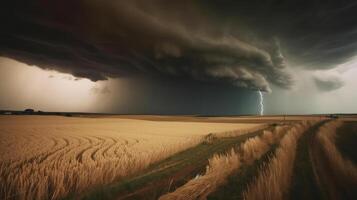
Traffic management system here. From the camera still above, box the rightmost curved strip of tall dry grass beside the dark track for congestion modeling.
[317,121,357,187]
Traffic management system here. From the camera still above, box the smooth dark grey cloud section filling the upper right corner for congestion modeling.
[201,0,357,69]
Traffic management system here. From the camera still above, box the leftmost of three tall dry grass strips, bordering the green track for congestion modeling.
[160,126,288,200]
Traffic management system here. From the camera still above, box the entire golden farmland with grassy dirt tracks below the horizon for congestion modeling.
[0,116,357,200]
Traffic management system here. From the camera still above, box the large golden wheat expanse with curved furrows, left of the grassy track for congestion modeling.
[0,116,257,199]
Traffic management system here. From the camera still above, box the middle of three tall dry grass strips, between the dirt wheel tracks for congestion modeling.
[243,122,310,200]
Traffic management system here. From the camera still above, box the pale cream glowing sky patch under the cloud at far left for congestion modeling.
[0,57,101,112]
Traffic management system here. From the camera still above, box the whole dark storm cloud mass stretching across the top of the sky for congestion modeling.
[0,0,357,91]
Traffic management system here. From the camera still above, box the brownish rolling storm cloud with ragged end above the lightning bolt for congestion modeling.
[0,0,291,91]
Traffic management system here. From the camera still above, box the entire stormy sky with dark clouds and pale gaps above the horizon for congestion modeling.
[0,0,357,115]
